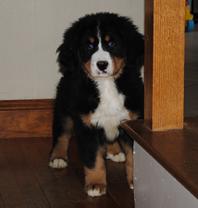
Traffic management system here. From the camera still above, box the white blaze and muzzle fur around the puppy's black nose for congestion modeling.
[91,32,113,77]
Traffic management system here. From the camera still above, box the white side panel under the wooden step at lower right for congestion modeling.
[134,142,198,208]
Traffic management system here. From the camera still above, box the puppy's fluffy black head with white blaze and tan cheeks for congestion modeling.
[58,13,143,79]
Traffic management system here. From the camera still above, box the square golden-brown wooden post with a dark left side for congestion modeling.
[144,0,185,131]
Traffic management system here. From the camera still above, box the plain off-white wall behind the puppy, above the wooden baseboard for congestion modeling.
[0,0,144,100]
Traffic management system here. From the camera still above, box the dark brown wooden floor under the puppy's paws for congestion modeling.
[0,138,134,208]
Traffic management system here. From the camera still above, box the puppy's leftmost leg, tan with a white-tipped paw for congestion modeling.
[49,118,73,169]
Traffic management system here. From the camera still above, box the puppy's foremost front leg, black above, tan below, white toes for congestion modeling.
[75,116,106,197]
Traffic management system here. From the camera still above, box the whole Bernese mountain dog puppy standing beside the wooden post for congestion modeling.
[49,13,144,196]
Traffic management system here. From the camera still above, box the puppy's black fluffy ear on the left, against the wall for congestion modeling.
[57,28,78,75]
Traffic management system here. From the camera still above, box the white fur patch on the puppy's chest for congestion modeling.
[91,78,129,141]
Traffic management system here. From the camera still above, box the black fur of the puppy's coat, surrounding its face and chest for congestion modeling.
[53,13,144,168]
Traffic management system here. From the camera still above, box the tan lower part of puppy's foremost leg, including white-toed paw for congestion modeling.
[84,148,106,197]
